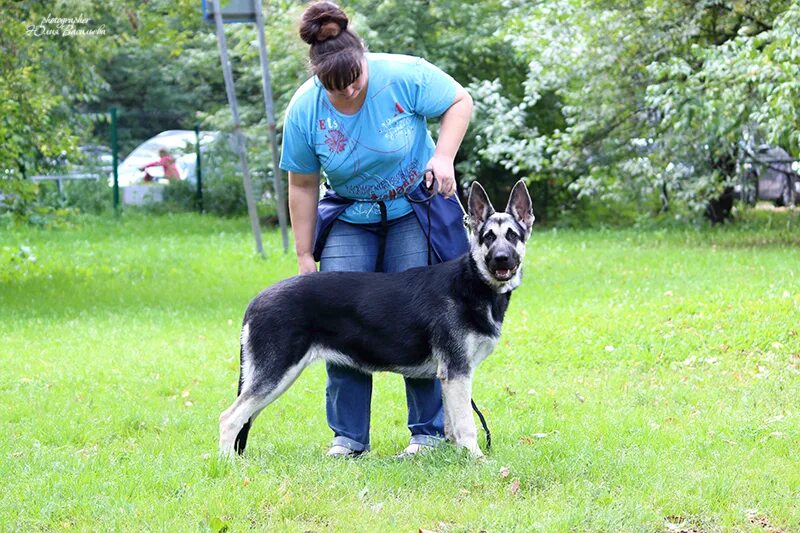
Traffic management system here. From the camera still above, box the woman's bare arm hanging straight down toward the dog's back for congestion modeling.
[289,171,319,274]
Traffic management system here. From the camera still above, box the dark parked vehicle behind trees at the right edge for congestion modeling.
[734,145,800,207]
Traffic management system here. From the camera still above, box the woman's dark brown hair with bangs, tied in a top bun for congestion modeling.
[300,1,365,90]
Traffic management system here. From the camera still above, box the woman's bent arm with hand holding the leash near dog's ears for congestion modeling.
[426,85,472,198]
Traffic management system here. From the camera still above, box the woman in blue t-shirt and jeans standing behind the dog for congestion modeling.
[280,2,472,456]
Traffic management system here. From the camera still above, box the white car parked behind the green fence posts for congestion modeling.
[109,130,219,187]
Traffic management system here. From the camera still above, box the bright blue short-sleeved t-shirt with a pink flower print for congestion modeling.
[280,54,458,224]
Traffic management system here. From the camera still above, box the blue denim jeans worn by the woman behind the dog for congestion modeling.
[319,213,444,451]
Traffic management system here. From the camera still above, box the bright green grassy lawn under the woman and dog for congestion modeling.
[0,213,800,532]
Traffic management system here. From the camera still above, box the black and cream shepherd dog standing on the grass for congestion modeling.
[219,180,534,457]
